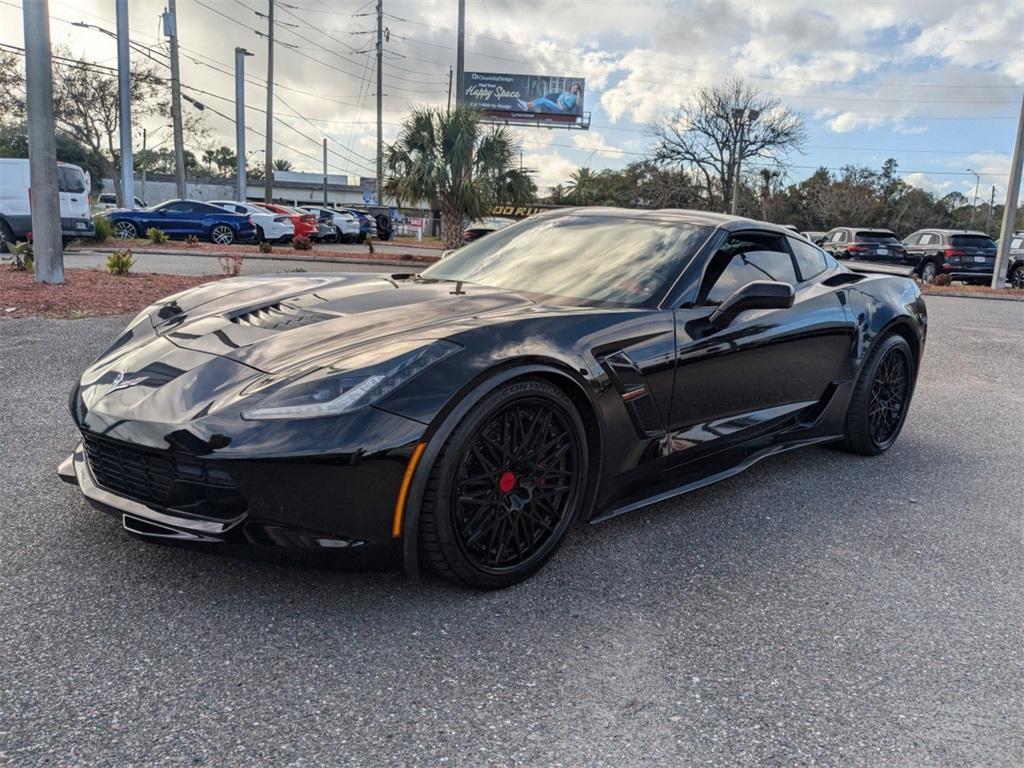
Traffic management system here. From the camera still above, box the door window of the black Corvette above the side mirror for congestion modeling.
[697,232,798,304]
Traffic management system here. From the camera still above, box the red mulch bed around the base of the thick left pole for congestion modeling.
[0,269,223,318]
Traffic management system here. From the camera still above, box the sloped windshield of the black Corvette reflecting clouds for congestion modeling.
[423,214,711,306]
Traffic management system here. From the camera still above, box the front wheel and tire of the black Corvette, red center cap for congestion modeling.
[419,379,588,590]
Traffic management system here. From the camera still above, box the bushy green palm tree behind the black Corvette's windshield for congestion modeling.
[383,106,536,248]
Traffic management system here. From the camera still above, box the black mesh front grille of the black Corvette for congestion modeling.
[82,432,246,520]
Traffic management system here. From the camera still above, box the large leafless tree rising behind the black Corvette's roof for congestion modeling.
[647,78,806,210]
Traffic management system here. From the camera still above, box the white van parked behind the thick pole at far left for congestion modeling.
[0,158,96,253]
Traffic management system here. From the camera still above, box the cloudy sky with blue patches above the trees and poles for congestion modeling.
[0,0,1024,197]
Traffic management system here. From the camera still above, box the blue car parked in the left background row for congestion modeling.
[97,200,256,246]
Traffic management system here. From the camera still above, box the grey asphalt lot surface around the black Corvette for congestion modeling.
[0,297,1024,768]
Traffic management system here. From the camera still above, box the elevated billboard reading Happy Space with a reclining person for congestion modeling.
[462,72,586,124]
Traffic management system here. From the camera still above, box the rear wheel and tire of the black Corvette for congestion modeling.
[842,334,915,456]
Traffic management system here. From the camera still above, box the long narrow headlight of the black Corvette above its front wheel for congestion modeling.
[242,341,462,420]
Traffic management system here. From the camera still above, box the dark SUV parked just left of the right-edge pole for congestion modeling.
[903,229,995,283]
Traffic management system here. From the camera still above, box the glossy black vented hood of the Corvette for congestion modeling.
[100,274,535,374]
